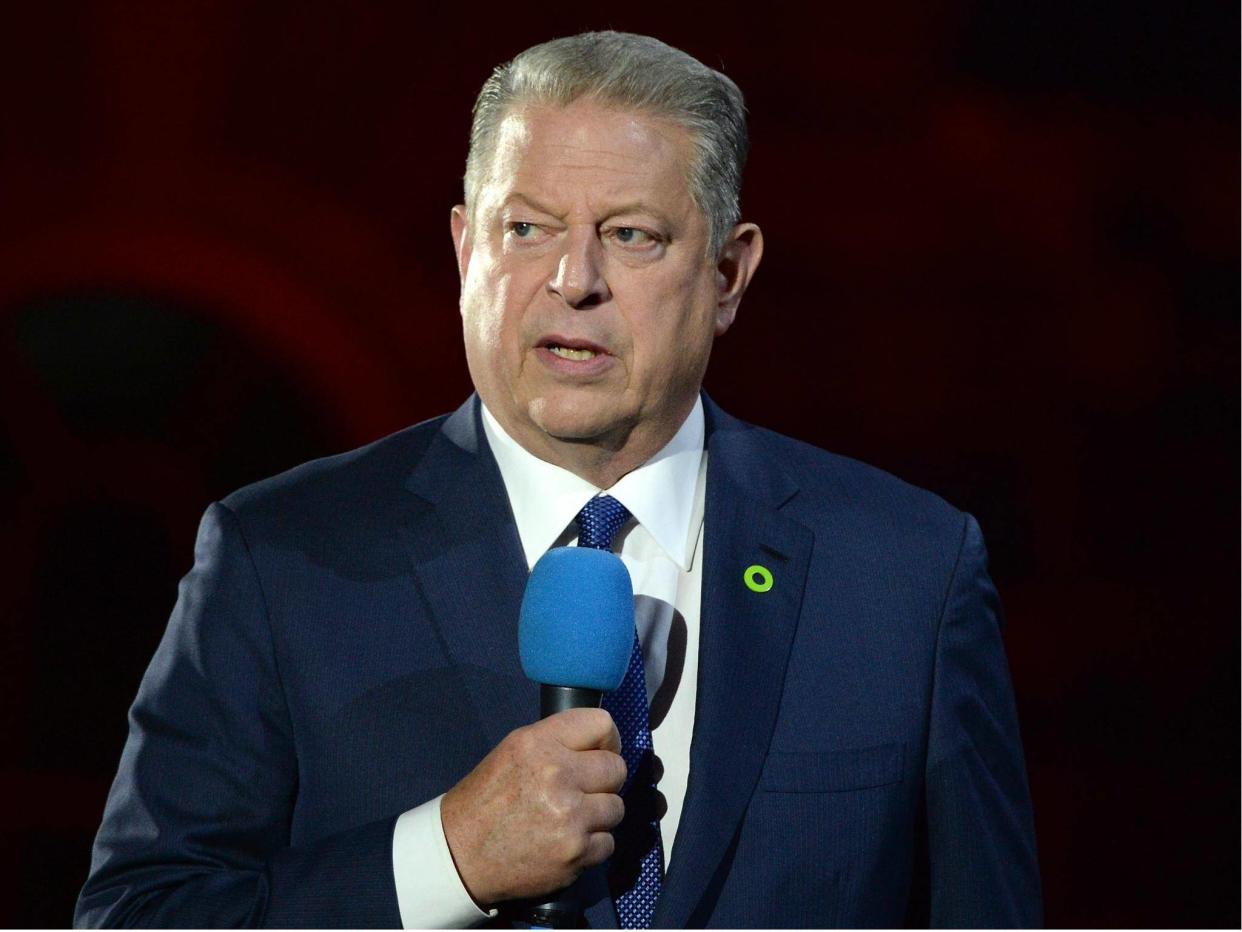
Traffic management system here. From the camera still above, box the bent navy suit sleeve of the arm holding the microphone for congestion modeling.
[75,505,401,928]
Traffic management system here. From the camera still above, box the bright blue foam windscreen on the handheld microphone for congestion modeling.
[518,547,635,692]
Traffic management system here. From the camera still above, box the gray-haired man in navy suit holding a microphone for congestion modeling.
[77,32,1040,927]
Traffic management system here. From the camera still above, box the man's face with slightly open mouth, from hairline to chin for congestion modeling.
[453,101,758,464]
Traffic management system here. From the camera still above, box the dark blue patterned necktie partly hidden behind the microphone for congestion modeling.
[575,495,664,928]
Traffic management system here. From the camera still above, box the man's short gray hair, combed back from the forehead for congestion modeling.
[466,31,749,255]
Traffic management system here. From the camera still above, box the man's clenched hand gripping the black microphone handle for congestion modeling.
[440,708,626,907]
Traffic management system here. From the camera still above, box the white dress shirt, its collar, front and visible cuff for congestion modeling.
[392,400,707,928]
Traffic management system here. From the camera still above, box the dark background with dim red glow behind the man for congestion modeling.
[0,1,1240,927]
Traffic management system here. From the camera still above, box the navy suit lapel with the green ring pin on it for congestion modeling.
[652,399,814,928]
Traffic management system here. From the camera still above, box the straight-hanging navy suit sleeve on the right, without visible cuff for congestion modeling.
[925,516,1042,928]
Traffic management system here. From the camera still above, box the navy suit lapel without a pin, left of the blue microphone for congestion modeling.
[401,396,539,748]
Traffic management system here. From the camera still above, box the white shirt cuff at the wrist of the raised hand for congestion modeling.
[392,795,497,928]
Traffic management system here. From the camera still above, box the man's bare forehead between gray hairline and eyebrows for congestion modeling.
[486,101,693,214]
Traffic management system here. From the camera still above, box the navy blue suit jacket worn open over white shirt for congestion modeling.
[76,399,1041,927]
